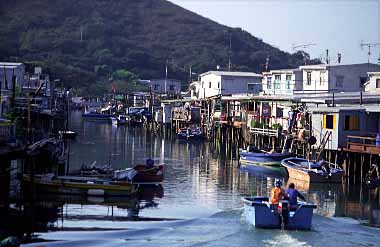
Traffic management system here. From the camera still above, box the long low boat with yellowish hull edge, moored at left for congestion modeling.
[23,174,137,196]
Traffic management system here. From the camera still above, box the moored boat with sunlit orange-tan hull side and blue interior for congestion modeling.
[281,158,344,183]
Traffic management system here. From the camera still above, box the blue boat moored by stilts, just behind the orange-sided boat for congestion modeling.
[239,146,295,166]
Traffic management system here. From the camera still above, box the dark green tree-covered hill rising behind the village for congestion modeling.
[0,0,316,91]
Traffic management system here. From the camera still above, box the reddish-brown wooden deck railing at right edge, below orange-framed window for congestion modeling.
[346,135,380,155]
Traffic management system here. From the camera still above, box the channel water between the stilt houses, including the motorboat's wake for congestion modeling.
[19,112,380,246]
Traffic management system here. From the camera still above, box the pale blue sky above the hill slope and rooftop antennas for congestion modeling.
[170,0,380,63]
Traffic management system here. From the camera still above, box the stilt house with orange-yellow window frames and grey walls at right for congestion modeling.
[309,104,380,151]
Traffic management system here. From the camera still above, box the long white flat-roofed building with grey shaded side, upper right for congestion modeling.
[262,63,380,95]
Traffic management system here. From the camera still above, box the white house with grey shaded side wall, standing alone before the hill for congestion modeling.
[198,71,262,99]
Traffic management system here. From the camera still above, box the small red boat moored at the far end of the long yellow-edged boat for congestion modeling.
[114,165,164,184]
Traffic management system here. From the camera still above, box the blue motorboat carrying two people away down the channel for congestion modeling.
[242,196,317,230]
